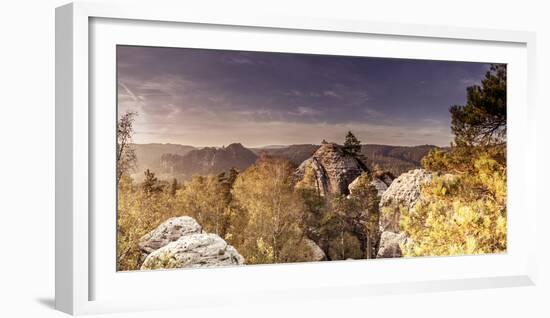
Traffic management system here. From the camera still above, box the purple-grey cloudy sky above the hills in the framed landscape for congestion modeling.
[117,46,496,147]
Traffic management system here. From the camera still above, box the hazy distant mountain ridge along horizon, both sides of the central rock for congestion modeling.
[130,143,438,181]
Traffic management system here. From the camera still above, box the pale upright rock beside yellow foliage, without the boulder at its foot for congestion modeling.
[380,169,432,232]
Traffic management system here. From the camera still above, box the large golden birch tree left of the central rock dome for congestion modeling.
[232,157,310,264]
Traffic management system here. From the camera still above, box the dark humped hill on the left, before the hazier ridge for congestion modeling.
[160,143,257,180]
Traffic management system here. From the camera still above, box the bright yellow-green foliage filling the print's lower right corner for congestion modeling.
[400,155,506,256]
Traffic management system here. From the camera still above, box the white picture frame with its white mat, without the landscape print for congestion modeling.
[55,2,537,314]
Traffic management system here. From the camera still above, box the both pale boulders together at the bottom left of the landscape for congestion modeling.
[139,216,244,269]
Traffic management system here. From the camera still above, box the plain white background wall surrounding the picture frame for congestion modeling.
[0,0,550,317]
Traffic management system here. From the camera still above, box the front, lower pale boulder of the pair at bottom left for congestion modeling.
[141,233,244,270]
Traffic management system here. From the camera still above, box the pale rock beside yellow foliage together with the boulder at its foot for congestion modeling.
[376,169,432,258]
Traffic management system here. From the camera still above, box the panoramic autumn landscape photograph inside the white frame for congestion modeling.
[113,45,507,271]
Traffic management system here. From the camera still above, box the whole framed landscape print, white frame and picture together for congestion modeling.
[56,3,536,314]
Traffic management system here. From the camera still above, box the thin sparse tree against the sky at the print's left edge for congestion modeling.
[116,112,137,184]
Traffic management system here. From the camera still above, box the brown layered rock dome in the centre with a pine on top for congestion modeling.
[295,143,368,196]
